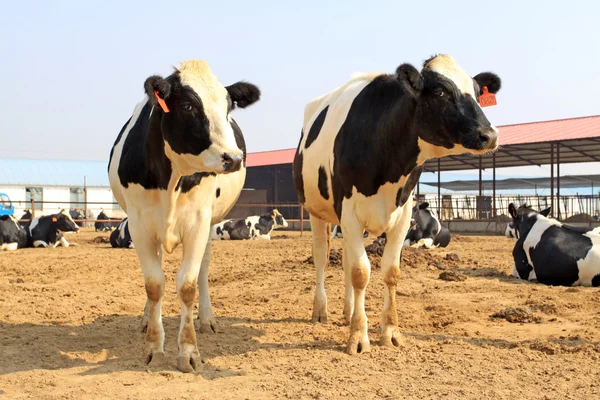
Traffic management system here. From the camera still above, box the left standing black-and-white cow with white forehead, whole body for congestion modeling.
[108,60,260,372]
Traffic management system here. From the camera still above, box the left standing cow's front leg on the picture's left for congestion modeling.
[130,223,165,366]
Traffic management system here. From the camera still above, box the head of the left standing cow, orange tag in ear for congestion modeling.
[144,60,260,175]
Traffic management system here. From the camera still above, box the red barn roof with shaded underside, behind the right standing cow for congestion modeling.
[247,115,600,172]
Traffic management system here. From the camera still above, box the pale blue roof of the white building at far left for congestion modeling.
[0,158,110,187]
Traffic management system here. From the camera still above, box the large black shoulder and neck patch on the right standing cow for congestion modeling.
[331,75,419,218]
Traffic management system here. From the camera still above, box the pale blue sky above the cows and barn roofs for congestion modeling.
[0,0,600,189]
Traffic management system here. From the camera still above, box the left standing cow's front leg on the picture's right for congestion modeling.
[177,210,211,372]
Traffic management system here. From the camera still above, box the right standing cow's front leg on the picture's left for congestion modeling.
[341,212,371,354]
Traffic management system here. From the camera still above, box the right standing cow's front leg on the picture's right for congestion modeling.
[379,202,411,347]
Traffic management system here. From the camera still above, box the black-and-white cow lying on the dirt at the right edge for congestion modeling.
[508,203,600,287]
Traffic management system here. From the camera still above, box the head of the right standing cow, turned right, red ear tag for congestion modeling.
[396,55,501,158]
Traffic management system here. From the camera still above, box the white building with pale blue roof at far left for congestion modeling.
[0,158,125,218]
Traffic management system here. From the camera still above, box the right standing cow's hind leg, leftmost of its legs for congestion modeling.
[310,215,331,323]
